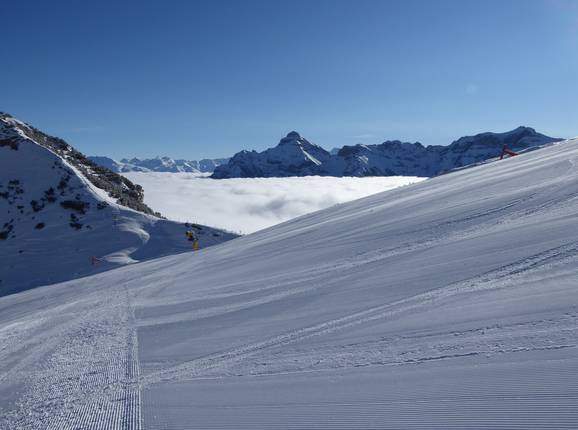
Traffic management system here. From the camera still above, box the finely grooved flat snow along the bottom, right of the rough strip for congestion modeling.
[144,359,578,430]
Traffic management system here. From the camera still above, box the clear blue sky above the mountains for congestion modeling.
[0,0,578,159]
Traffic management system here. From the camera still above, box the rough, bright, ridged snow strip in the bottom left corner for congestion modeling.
[0,286,141,430]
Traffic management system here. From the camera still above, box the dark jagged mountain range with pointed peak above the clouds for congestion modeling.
[212,127,560,179]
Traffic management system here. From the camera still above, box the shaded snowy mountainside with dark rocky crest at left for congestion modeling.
[0,113,234,296]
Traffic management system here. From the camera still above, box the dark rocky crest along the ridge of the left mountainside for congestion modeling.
[0,112,160,216]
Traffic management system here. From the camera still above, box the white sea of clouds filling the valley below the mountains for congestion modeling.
[123,172,424,234]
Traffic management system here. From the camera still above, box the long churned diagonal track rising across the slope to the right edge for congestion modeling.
[141,243,578,386]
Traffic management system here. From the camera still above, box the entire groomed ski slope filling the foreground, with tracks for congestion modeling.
[0,140,578,429]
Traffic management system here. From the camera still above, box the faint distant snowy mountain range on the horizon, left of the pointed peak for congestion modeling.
[88,156,229,173]
